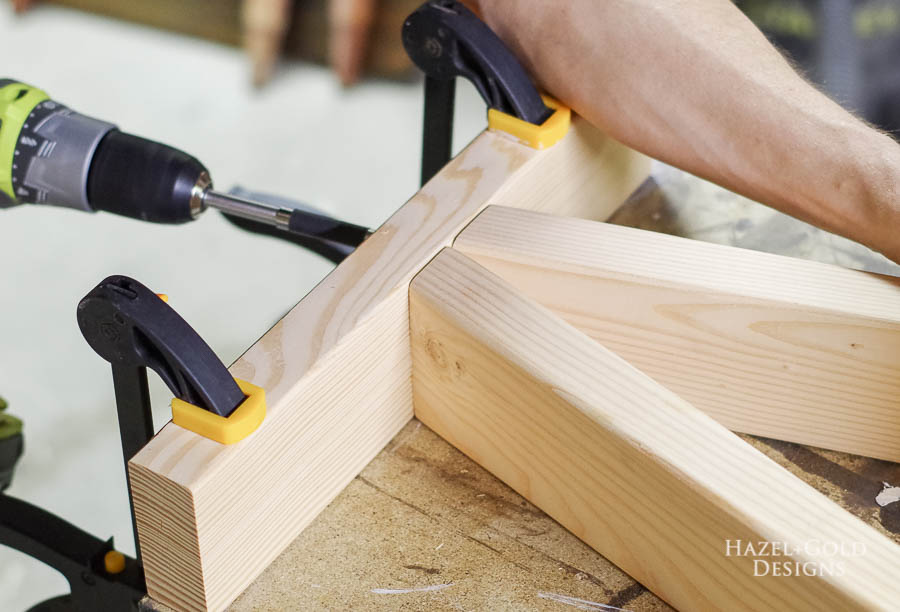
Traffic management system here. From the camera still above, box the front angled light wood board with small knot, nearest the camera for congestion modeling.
[410,249,900,612]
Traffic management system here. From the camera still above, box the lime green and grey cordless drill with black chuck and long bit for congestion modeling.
[0,79,369,246]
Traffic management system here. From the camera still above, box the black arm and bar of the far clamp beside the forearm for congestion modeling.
[403,0,553,184]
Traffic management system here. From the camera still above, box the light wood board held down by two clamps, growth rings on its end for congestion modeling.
[129,120,649,610]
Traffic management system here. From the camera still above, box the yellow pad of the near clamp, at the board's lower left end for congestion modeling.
[172,378,266,444]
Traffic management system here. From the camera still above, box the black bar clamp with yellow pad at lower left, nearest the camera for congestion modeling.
[0,276,265,612]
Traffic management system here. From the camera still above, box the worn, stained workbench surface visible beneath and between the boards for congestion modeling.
[151,168,900,611]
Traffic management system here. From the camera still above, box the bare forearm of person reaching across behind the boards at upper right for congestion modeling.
[480,0,900,260]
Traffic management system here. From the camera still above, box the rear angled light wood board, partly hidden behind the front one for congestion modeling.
[455,207,900,461]
